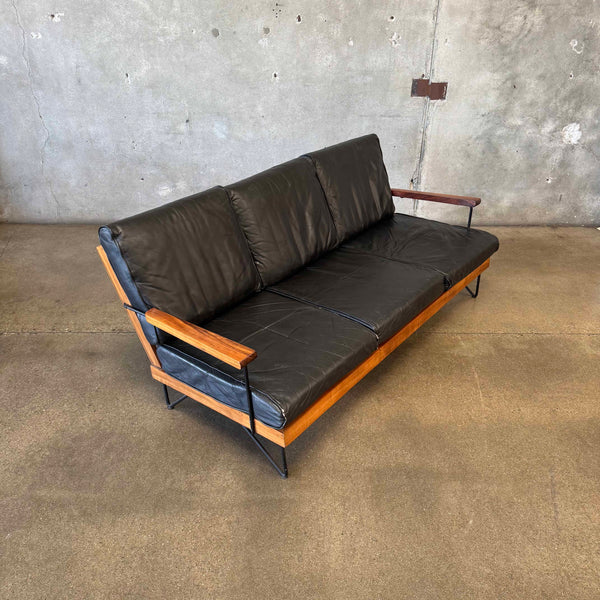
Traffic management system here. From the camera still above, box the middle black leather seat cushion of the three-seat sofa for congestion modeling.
[268,249,444,345]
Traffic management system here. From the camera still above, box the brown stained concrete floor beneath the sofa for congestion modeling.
[0,225,600,600]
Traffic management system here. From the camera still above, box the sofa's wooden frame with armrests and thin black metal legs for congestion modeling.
[96,189,490,478]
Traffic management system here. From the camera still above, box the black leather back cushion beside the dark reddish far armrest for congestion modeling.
[307,134,394,242]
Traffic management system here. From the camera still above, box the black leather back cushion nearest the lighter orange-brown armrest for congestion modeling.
[100,188,260,323]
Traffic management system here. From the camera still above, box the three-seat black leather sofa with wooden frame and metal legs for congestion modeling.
[98,135,498,476]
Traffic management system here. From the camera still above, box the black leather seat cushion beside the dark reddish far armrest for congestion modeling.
[342,213,498,286]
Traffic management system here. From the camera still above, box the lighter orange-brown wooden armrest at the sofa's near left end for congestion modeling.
[144,308,256,369]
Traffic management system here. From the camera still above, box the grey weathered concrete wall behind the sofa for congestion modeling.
[0,0,600,224]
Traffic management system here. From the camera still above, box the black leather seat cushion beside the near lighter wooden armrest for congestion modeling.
[157,291,377,429]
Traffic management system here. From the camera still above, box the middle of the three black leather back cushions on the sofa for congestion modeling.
[227,157,336,285]
